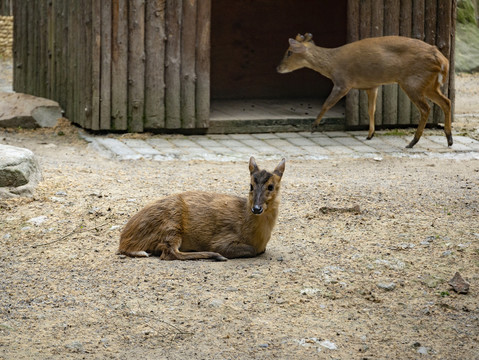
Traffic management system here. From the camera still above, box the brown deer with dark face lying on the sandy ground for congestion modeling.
[118,157,285,261]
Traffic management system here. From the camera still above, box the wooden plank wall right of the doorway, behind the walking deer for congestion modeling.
[346,0,457,128]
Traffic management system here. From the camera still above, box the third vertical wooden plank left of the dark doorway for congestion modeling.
[165,0,182,129]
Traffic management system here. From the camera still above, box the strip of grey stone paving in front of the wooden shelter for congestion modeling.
[82,131,479,161]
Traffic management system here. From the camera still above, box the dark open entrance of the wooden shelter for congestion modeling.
[210,0,347,131]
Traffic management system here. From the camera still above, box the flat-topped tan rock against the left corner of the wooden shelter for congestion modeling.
[0,92,62,129]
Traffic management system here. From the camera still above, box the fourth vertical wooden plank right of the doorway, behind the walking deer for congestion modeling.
[382,0,399,125]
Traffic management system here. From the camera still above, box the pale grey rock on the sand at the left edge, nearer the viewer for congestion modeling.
[0,144,42,199]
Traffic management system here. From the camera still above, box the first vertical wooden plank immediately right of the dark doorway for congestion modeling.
[346,0,359,127]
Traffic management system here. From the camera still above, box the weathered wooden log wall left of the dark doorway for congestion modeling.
[14,0,211,132]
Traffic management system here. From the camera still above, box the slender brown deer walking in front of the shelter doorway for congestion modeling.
[277,33,452,148]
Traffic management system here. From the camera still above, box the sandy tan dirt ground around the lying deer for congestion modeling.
[0,75,479,359]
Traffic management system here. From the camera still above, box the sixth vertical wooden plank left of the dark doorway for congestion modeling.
[111,0,128,130]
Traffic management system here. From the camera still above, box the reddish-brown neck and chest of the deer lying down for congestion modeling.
[243,198,279,253]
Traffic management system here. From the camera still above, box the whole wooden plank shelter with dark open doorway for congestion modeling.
[14,0,456,132]
